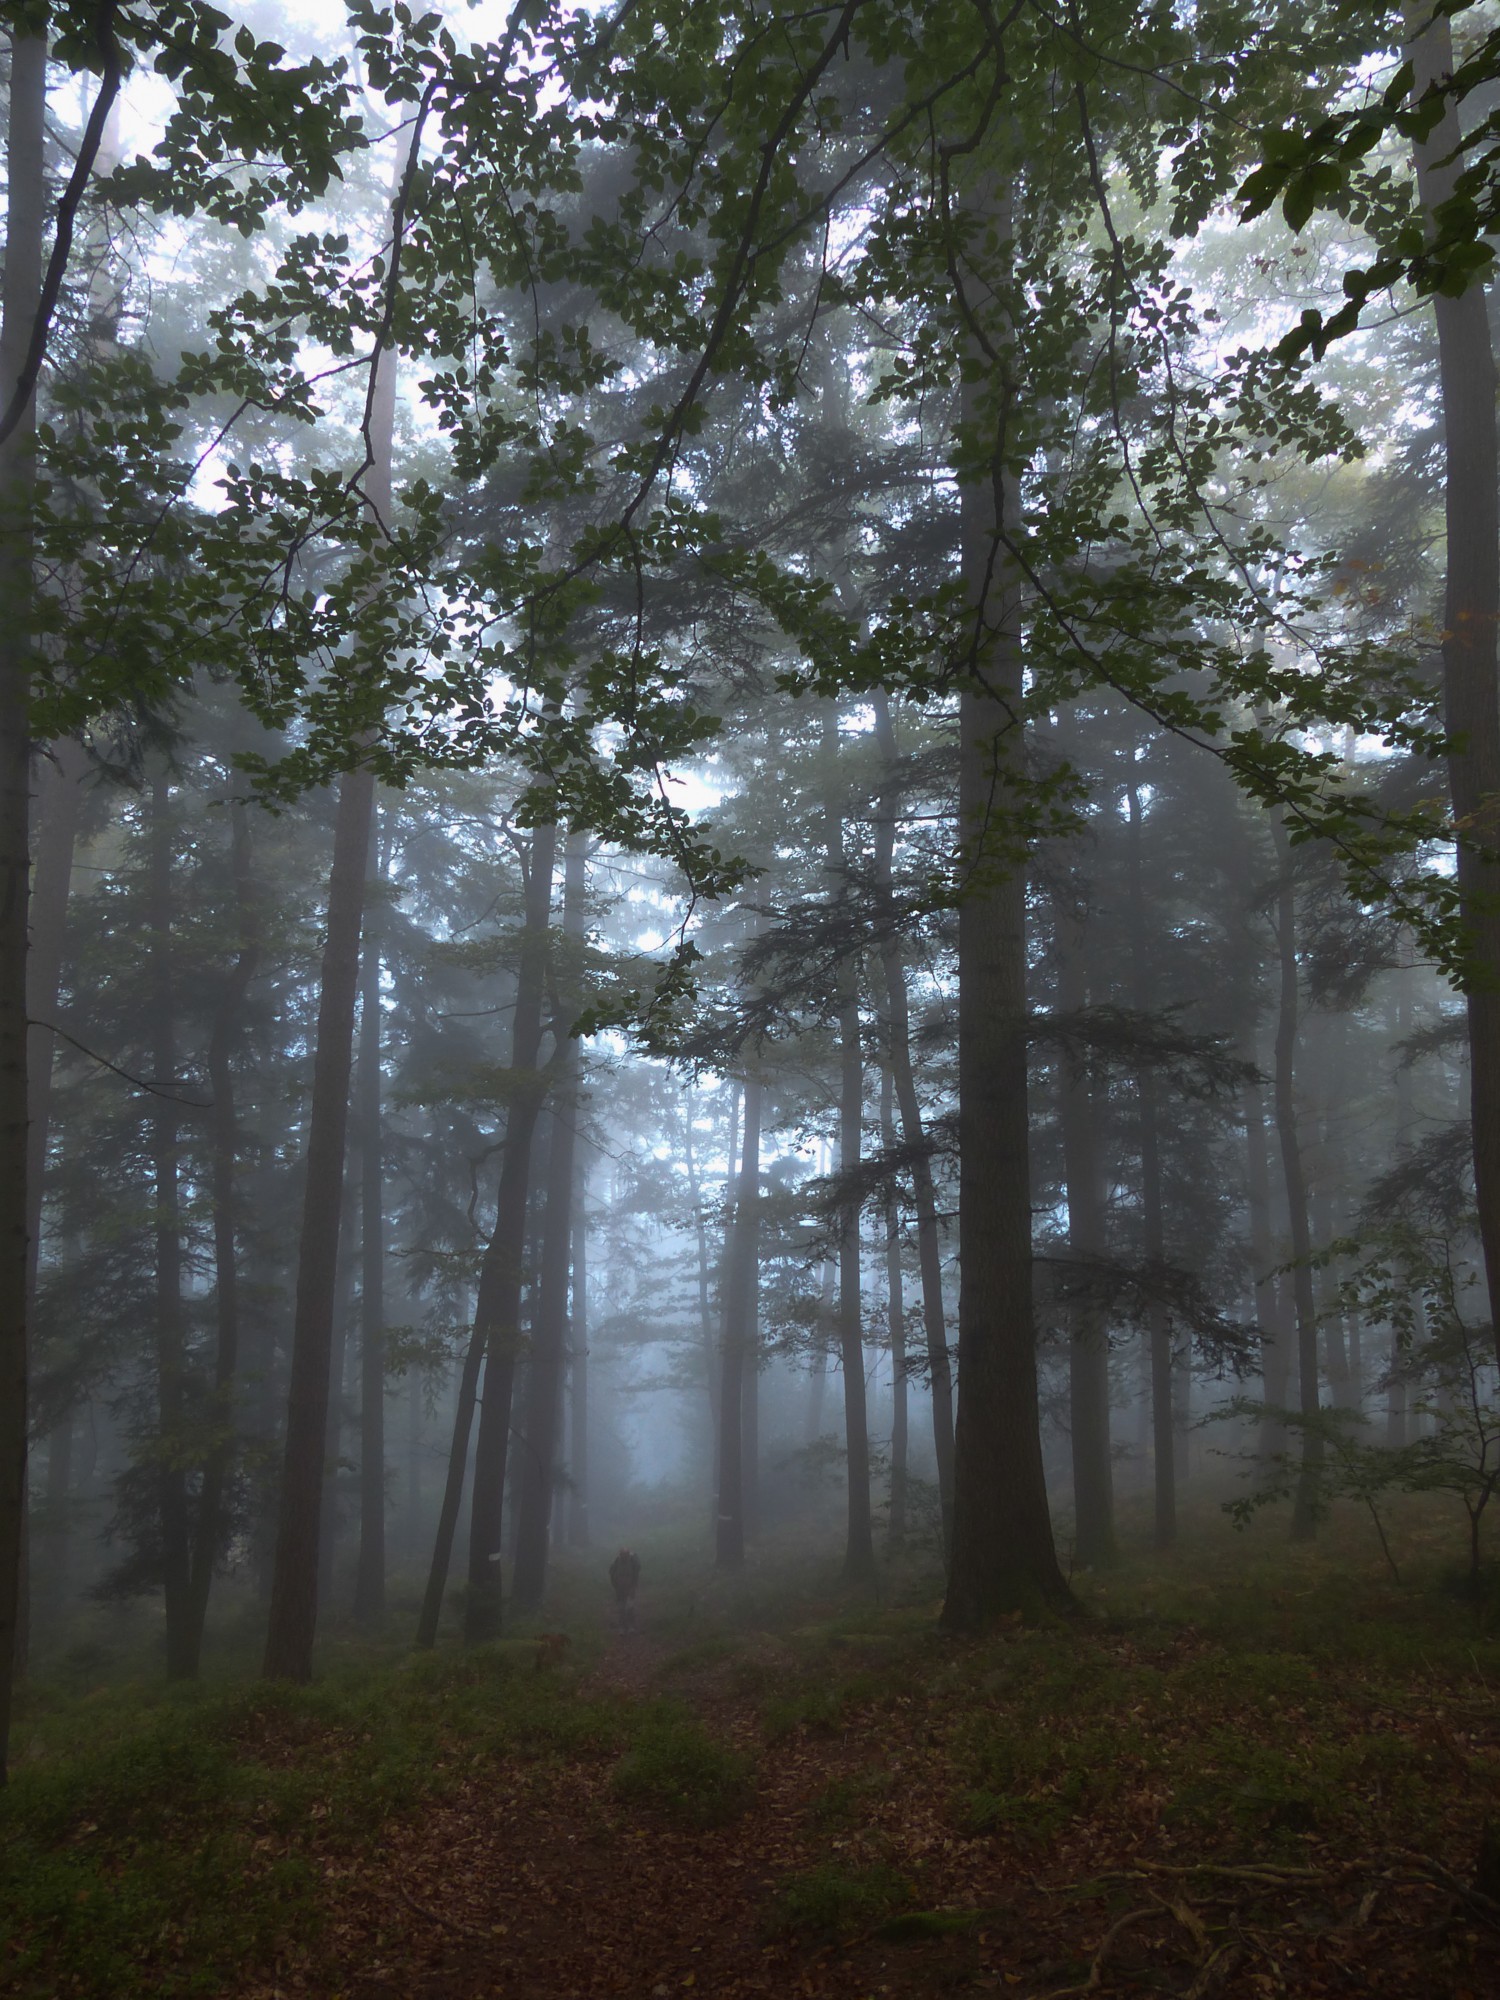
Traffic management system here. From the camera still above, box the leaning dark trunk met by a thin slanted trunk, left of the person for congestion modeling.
[458,826,558,1642]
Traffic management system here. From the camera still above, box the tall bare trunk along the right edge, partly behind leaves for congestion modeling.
[1404,0,1500,1340]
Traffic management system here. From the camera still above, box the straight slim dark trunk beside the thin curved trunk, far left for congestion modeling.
[146,778,198,1680]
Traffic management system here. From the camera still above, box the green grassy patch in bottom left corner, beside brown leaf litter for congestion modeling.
[0,1642,636,2000]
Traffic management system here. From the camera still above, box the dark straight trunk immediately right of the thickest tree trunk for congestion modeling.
[1058,914,1118,1570]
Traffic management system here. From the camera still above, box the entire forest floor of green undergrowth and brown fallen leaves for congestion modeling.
[0,1504,1500,2000]
